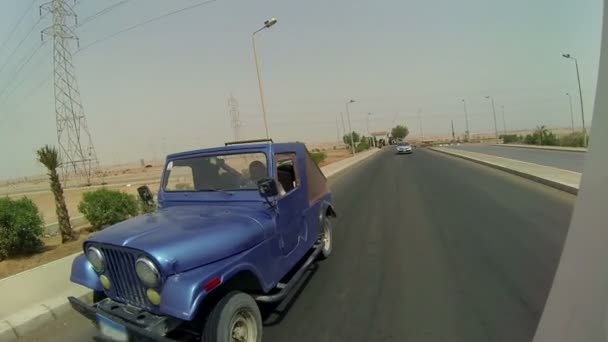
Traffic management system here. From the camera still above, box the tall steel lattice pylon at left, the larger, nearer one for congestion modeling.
[40,0,99,184]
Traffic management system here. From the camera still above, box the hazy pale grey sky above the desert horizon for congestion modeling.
[0,0,602,178]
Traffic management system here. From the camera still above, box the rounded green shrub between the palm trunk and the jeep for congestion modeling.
[78,189,139,230]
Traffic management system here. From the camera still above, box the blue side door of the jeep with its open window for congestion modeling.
[273,152,307,257]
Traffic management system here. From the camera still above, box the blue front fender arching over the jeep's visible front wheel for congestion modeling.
[160,240,278,321]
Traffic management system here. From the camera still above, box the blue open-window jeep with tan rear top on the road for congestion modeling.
[69,140,336,342]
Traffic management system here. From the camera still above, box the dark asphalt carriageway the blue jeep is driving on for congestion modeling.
[23,149,575,342]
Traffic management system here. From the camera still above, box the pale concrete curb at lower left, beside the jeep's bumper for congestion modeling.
[0,289,93,342]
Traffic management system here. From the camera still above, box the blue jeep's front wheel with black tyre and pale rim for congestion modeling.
[201,291,262,342]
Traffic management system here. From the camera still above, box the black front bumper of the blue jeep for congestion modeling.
[68,297,181,342]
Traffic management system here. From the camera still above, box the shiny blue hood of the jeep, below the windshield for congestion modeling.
[87,205,271,275]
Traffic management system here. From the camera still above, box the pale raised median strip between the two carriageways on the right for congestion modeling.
[431,147,581,195]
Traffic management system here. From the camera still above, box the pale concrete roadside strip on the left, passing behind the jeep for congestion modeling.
[0,148,380,342]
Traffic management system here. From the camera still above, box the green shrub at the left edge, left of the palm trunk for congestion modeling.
[0,197,44,260]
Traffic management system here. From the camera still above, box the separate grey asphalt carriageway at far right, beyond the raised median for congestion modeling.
[451,145,586,173]
